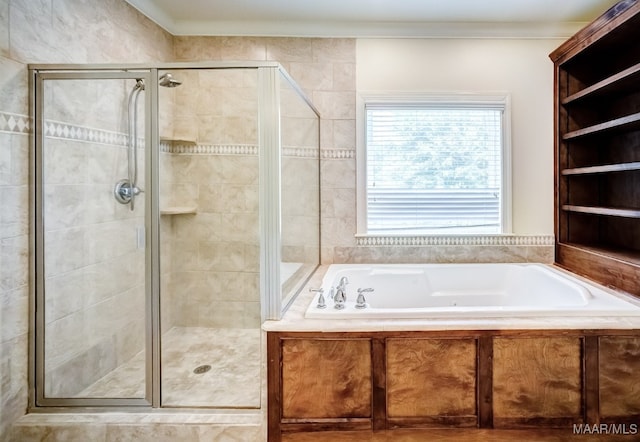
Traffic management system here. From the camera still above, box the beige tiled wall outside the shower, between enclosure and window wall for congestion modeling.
[175,37,356,263]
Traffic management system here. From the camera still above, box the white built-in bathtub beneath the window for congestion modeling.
[305,264,640,319]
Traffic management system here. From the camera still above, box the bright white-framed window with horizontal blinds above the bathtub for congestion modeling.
[359,97,509,235]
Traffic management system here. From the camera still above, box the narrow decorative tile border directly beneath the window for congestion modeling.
[356,235,555,246]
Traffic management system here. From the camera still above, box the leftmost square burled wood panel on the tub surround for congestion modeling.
[282,339,371,418]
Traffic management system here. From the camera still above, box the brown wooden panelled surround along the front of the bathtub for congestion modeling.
[267,330,640,442]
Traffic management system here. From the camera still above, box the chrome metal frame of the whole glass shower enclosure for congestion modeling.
[29,61,320,412]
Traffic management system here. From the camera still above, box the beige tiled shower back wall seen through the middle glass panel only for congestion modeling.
[160,69,260,329]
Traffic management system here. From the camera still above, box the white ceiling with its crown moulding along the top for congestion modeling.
[126,0,617,38]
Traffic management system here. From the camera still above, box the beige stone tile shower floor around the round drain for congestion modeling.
[78,327,261,408]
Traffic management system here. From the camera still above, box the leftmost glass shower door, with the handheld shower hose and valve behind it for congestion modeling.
[35,72,151,405]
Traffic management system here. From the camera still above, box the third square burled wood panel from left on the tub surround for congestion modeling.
[493,337,582,426]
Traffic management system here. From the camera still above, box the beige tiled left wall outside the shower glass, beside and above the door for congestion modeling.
[0,0,173,440]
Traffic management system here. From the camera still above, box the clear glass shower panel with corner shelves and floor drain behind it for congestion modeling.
[158,68,262,408]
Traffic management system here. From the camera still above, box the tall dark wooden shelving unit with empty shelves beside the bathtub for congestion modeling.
[550,0,640,296]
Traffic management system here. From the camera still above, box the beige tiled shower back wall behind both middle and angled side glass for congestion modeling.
[160,69,319,330]
